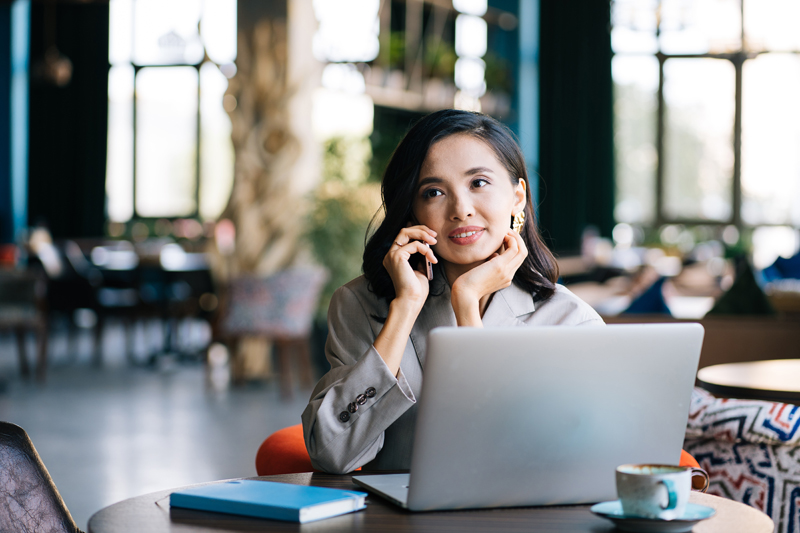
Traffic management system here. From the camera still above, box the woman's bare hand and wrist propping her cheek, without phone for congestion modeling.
[450,229,528,326]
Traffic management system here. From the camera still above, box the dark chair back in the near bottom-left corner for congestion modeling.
[0,422,81,533]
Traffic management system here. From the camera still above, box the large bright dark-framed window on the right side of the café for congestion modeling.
[612,0,800,228]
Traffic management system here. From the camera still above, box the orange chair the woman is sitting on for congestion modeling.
[256,424,700,476]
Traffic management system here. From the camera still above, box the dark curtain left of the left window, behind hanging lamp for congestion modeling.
[28,2,109,238]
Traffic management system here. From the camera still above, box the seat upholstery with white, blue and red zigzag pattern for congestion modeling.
[684,388,800,533]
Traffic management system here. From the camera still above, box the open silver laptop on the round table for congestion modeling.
[353,324,704,511]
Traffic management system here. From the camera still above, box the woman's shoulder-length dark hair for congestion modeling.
[363,109,558,302]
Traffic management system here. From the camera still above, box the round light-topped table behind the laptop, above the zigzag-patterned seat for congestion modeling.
[697,359,800,404]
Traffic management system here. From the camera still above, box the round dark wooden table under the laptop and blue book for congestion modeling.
[89,473,774,533]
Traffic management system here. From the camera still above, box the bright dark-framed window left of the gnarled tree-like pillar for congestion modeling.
[106,0,236,222]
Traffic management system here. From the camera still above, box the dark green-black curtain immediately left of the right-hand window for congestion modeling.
[538,0,614,254]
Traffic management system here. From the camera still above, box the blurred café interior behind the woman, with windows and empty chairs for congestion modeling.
[0,0,800,533]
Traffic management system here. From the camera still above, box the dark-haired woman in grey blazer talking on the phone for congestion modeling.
[303,110,603,473]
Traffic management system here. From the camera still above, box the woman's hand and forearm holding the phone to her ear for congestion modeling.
[373,226,439,376]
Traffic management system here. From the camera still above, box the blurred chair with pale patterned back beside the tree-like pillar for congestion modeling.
[215,267,328,397]
